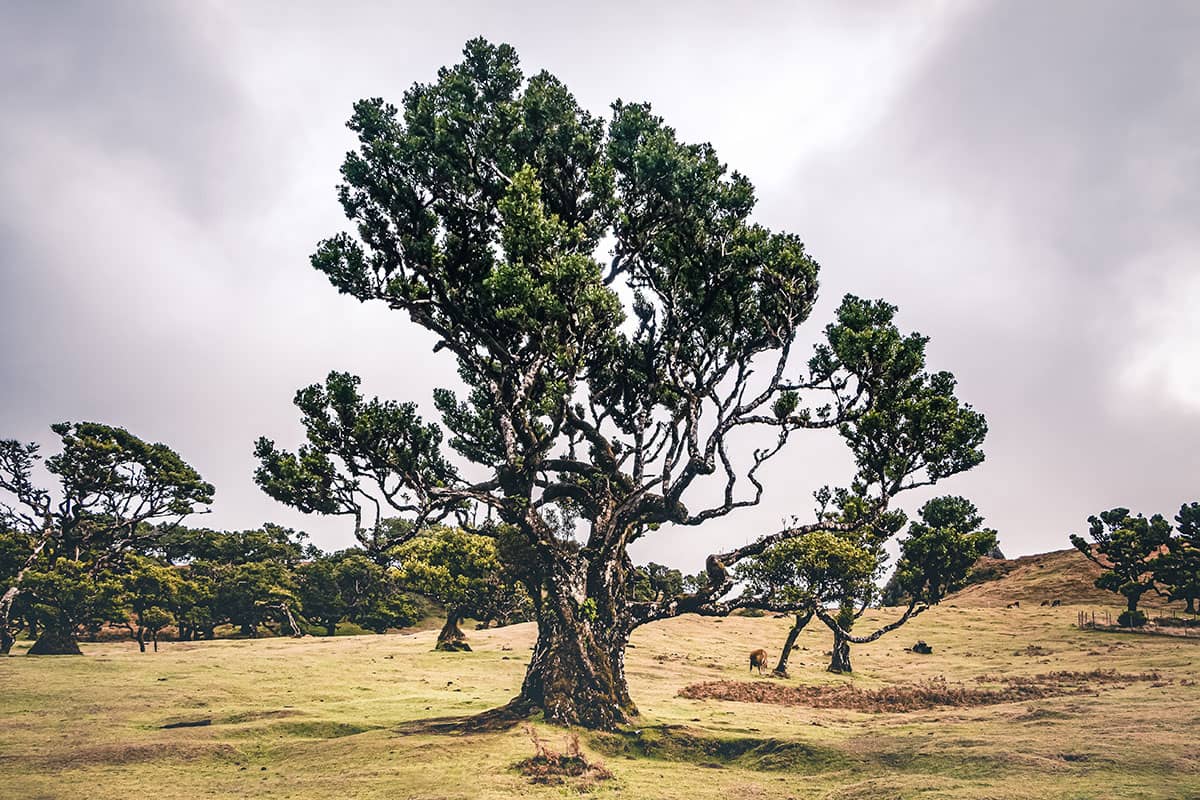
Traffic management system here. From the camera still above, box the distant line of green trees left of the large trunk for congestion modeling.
[0,524,530,650]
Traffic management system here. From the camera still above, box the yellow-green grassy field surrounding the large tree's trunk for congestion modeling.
[0,606,1200,800]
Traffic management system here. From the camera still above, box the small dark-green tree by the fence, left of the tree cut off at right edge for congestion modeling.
[1070,509,1171,627]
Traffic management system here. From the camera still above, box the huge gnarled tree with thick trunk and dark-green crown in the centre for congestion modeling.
[257,40,985,728]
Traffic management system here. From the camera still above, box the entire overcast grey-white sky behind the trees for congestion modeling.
[0,0,1200,570]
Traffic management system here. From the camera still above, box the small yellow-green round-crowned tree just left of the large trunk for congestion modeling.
[391,525,511,650]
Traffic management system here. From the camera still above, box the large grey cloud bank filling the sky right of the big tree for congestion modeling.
[729,2,1200,563]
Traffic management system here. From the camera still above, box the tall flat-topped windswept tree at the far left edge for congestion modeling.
[0,422,214,654]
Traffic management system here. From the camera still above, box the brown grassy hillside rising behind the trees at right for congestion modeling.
[946,548,1183,609]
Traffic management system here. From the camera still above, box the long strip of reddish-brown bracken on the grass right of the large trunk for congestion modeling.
[679,669,1163,714]
